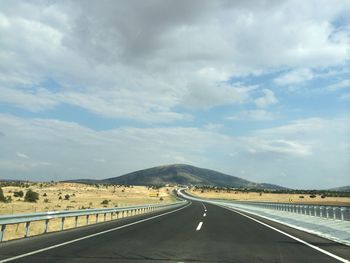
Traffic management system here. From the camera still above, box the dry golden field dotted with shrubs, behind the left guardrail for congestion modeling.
[0,183,175,241]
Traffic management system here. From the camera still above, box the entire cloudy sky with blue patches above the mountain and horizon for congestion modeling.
[0,0,350,188]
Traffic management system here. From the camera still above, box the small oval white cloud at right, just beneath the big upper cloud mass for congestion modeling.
[274,68,314,86]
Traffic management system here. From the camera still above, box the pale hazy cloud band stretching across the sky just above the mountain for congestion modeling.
[0,114,350,188]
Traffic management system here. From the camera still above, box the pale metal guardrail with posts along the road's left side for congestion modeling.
[0,201,187,242]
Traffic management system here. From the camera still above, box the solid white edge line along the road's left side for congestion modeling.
[0,202,192,263]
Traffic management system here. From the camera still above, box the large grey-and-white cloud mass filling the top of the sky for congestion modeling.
[0,1,350,123]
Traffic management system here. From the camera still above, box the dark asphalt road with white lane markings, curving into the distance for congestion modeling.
[0,202,350,263]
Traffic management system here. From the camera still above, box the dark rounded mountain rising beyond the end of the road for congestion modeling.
[65,164,287,190]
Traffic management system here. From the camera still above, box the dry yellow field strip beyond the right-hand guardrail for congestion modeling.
[188,189,350,206]
